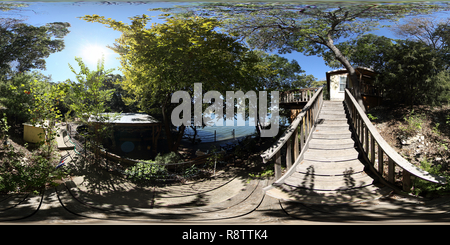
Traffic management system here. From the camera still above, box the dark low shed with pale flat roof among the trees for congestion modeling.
[89,113,162,157]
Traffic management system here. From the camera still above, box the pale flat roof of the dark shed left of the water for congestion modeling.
[89,113,160,126]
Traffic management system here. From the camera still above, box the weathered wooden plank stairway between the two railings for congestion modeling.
[266,101,391,204]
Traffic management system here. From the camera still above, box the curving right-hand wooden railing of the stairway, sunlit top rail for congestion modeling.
[345,89,446,191]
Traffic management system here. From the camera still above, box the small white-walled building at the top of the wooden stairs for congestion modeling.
[326,67,382,109]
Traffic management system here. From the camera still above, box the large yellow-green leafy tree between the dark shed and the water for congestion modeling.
[82,15,258,152]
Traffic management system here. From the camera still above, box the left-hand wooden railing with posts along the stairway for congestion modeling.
[261,87,323,179]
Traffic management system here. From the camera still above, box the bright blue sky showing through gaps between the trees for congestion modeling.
[5,2,444,82]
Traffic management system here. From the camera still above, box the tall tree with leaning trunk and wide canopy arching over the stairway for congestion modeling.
[153,3,447,111]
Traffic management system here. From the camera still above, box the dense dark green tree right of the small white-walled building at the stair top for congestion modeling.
[377,41,445,106]
